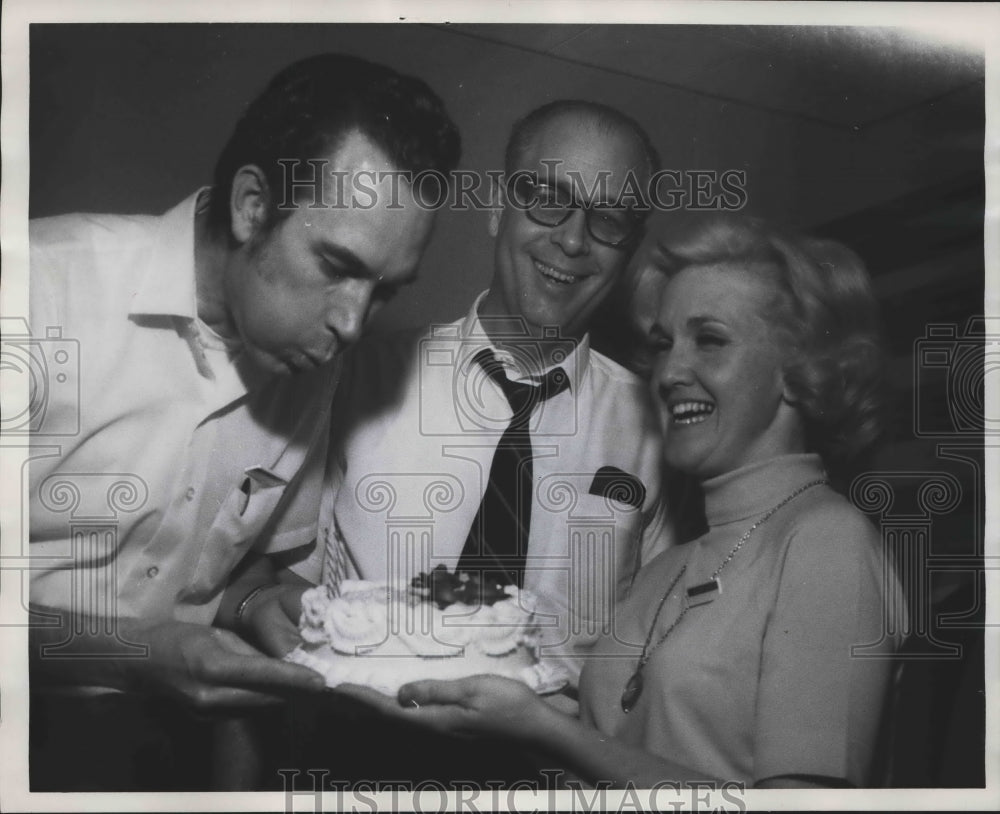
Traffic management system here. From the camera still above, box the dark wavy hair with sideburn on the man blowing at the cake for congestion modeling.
[209,54,461,233]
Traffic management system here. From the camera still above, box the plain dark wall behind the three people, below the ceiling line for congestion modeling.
[30,24,982,334]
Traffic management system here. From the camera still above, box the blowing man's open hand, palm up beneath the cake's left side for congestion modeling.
[126,621,325,707]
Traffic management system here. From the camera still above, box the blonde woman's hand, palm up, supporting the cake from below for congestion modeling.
[337,675,559,740]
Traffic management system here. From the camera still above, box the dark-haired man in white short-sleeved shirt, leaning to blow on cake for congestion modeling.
[29,54,459,706]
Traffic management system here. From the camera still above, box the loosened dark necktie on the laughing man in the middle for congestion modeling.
[458,348,569,587]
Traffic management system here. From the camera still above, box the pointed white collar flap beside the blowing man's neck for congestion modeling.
[129,187,210,320]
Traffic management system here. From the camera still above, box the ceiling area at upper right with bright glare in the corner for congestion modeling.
[434,24,984,130]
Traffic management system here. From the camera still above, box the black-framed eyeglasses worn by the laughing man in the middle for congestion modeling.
[507,173,643,249]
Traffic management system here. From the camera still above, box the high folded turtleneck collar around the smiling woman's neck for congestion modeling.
[702,453,826,526]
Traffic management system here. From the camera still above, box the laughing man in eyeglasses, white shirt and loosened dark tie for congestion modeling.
[297,101,663,712]
